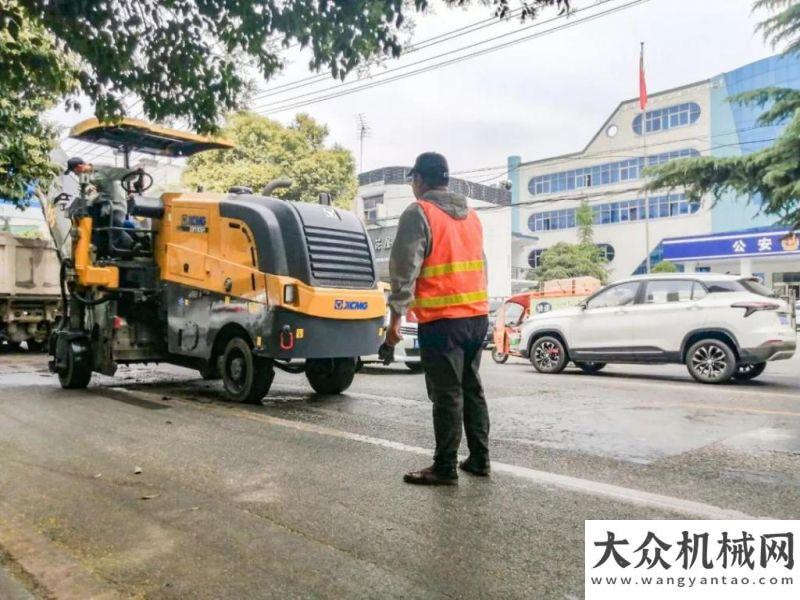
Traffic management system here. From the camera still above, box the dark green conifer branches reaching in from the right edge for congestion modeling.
[647,0,800,229]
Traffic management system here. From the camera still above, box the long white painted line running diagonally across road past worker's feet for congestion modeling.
[113,388,766,520]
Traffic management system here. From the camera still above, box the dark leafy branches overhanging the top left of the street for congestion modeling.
[0,0,569,206]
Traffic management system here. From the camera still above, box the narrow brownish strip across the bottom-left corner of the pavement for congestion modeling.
[0,503,124,600]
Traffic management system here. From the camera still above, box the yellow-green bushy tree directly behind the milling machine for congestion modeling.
[184,112,357,206]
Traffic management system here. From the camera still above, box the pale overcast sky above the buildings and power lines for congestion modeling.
[51,0,773,181]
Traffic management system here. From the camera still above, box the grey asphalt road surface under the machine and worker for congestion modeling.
[0,344,800,598]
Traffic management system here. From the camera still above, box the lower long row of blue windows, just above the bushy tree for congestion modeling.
[528,194,700,232]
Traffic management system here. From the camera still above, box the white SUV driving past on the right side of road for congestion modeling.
[520,273,797,383]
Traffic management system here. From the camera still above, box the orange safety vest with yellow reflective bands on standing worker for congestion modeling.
[411,200,489,323]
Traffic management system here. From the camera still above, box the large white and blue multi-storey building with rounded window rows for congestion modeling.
[508,57,800,292]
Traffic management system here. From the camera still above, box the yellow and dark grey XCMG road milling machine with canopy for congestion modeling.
[48,119,386,402]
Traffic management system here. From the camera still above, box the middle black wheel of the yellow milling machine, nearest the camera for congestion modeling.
[221,337,275,404]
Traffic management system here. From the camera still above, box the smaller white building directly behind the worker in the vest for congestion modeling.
[354,167,511,296]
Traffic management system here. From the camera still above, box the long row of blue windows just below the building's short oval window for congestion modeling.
[528,148,700,196]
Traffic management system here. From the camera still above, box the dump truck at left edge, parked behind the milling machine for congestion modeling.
[0,232,60,351]
